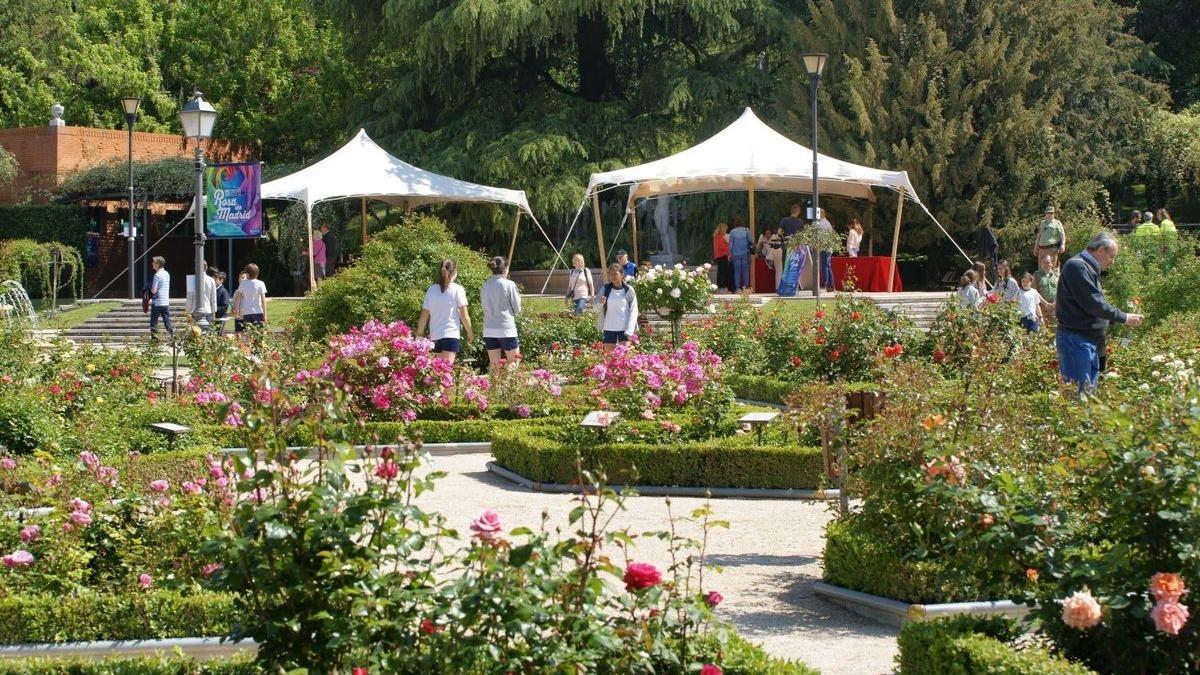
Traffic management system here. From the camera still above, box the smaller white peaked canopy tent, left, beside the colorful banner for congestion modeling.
[262,130,554,285]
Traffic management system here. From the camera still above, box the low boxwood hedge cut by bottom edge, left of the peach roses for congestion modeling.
[898,616,1094,675]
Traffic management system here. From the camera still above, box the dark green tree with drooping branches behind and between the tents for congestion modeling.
[325,0,794,251]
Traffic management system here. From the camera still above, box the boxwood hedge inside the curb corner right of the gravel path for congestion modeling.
[822,515,1003,603]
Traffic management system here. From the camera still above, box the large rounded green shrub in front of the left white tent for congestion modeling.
[295,213,491,343]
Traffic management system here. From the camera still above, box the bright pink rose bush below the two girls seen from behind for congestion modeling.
[295,319,488,422]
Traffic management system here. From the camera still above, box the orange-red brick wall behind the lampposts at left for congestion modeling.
[0,126,248,204]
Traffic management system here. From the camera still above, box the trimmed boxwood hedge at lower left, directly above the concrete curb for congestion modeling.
[0,590,236,645]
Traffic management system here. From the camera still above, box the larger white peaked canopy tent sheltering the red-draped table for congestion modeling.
[566,108,970,287]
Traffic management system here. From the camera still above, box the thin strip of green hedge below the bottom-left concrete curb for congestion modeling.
[0,656,263,675]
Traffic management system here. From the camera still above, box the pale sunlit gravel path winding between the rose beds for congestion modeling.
[408,453,896,675]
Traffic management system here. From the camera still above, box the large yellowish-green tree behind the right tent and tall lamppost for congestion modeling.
[780,0,1160,247]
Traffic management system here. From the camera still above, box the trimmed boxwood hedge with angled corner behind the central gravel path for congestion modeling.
[492,424,824,489]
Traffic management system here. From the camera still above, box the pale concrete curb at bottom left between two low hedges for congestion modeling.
[0,638,258,661]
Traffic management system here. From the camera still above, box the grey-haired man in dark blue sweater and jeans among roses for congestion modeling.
[1055,232,1142,393]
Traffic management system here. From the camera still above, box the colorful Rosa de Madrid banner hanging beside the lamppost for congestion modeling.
[204,162,263,239]
